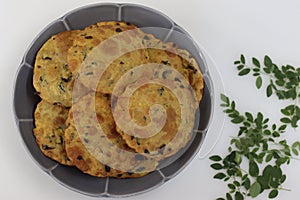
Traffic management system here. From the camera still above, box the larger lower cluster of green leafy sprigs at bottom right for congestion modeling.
[210,94,300,200]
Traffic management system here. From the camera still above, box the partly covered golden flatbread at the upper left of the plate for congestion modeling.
[33,31,80,107]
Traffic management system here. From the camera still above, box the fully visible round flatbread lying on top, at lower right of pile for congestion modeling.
[114,80,196,160]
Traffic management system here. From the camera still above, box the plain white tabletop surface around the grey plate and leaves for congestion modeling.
[0,0,300,200]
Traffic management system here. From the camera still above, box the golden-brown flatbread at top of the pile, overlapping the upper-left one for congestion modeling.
[68,22,148,94]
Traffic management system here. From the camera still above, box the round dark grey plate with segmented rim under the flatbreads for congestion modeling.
[13,4,213,197]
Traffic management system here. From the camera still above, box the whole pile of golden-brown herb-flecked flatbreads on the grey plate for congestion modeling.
[33,21,204,178]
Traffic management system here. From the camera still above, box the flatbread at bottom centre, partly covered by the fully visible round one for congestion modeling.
[65,93,157,178]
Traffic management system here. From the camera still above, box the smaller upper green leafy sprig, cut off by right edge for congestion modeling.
[234,54,300,128]
